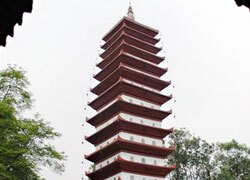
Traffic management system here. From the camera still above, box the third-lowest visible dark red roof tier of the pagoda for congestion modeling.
[85,116,173,146]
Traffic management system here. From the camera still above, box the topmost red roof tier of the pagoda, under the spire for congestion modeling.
[102,16,159,41]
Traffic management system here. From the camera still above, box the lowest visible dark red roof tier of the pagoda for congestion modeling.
[86,156,176,180]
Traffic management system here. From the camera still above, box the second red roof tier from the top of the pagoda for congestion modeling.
[101,24,160,49]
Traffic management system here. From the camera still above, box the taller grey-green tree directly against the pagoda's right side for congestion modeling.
[167,128,213,180]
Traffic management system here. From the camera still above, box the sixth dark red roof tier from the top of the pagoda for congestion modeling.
[91,64,171,95]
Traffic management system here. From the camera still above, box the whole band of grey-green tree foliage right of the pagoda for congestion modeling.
[167,129,250,180]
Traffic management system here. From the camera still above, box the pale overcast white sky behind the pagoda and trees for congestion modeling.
[0,0,250,180]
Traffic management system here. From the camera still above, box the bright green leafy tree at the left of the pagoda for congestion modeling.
[0,66,65,180]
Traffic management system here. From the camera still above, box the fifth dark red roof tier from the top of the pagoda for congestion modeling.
[94,52,167,81]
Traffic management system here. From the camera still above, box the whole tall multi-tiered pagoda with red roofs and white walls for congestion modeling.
[85,7,174,180]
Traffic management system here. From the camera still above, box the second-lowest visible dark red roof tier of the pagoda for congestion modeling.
[85,136,175,163]
